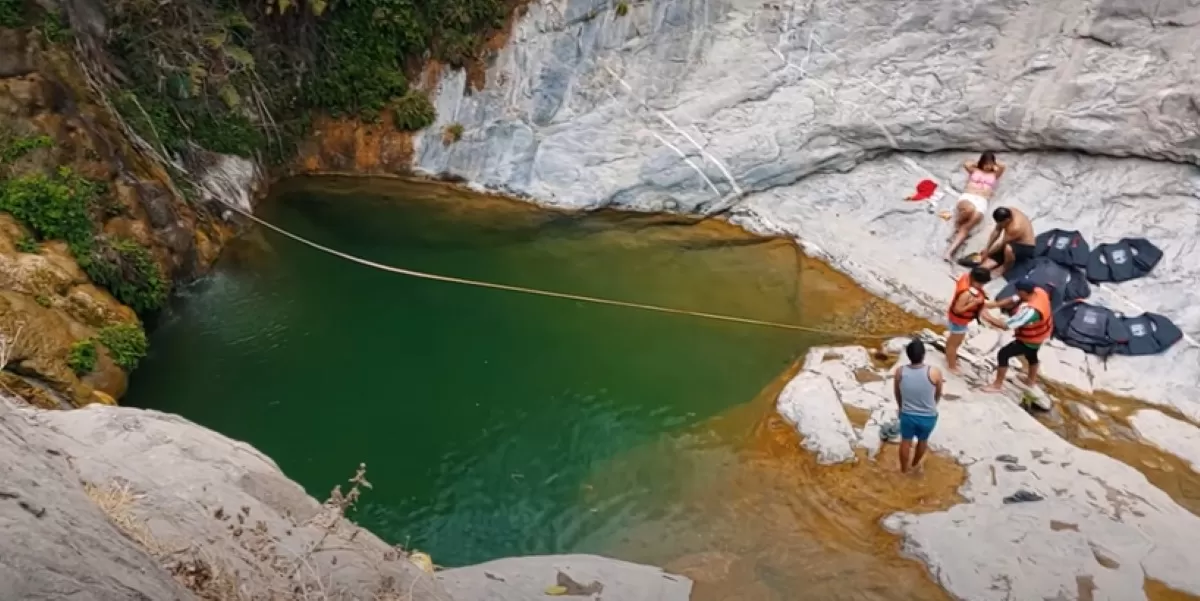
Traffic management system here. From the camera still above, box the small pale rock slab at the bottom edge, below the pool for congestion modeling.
[438,555,691,601]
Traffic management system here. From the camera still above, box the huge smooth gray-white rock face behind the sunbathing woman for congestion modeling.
[414,0,1200,412]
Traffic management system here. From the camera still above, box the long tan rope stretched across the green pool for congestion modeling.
[223,203,911,339]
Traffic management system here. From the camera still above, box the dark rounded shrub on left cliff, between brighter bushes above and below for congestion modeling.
[79,238,168,314]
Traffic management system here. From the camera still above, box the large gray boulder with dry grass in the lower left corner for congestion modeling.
[0,401,448,601]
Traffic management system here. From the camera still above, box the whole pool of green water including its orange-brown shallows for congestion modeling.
[126,175,945,600]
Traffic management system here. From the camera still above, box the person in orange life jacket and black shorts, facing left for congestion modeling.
[980,280,1054,392]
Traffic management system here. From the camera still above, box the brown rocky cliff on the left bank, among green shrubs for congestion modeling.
[0,19,260,407]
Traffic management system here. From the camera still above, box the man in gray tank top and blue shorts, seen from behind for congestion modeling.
[893,339,943,473]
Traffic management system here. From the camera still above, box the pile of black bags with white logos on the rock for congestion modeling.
[993,229,1183,356]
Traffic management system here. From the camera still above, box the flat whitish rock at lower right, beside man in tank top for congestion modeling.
[780,348,1200,601]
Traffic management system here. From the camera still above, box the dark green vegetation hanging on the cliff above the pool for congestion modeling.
[105,0,516,162]
